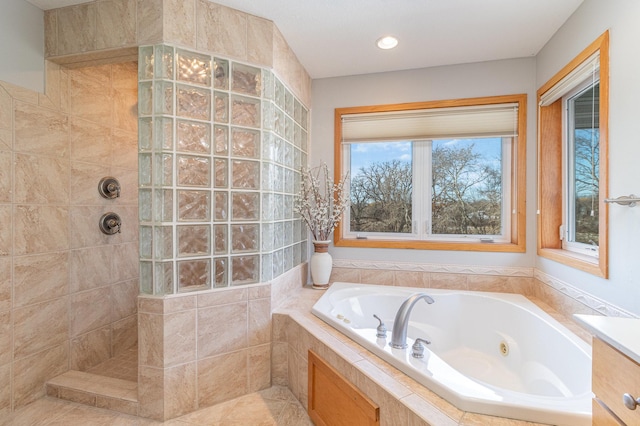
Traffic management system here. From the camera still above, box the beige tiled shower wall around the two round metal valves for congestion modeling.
[0,62,138,417]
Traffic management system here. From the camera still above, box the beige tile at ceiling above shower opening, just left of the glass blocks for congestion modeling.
[96,0,136,49]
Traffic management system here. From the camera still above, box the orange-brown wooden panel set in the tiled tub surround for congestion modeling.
[308,351,380,426]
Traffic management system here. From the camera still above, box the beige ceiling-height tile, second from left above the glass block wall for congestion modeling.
[163,0,196,48]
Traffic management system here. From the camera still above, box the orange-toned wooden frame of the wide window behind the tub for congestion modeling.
[334,94,527,253]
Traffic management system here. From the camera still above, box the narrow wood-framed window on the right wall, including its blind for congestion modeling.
[538,33,609,277]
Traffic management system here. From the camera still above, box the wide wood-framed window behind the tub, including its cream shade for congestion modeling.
[335,95,526,251]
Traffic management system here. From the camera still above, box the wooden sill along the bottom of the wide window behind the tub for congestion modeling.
[333,237,526,253]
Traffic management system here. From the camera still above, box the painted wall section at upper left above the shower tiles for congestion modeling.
[0,0,44,92]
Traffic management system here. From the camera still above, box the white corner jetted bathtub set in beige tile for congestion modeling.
[312,283,593,425]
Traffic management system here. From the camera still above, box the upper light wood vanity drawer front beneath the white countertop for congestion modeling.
[592,338,640,425]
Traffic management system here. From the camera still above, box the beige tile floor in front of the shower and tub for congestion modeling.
[6,386,313,426]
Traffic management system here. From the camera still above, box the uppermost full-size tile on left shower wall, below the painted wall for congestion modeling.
[14,102,69,158]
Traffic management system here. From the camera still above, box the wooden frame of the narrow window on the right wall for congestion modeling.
[537,31,609,278]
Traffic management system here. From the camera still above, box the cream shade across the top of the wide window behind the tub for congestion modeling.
[342,103,518,143]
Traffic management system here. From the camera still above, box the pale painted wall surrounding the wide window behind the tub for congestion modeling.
[310,58,536,267]
